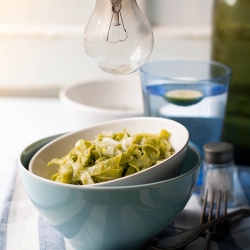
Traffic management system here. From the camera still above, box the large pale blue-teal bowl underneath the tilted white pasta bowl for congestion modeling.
[19,135,201,250]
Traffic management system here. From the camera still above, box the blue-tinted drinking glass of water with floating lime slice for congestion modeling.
[140,59,231,185]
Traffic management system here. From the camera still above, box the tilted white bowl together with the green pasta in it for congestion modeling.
[29,117,189,186]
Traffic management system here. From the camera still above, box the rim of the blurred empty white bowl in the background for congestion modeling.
[59,80,145,115]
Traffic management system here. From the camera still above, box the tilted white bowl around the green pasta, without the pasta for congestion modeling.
[29,117,189,186]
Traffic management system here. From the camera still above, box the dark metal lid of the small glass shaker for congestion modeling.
[203,142,234,164]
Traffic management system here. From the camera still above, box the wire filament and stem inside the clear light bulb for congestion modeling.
[106,0,128,43]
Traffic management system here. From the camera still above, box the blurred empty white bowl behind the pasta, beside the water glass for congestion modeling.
[59,80,144,129]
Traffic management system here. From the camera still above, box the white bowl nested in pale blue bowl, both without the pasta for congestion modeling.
[19,117,200,250]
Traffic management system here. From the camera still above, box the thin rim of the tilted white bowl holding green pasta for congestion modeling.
[27,117,192,188]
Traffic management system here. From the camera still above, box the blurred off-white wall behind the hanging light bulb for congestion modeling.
[0,0,213,96]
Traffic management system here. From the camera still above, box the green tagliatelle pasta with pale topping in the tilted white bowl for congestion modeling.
[47,129,174,185]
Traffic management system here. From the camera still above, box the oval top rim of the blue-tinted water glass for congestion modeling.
[140,58,232,82]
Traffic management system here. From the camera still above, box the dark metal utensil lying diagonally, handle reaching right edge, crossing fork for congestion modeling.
[148,203,250,250]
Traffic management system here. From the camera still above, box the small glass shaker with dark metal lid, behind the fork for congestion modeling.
[200,142,234,204]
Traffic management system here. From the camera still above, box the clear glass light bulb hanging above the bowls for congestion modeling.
[84,0,154,75]
